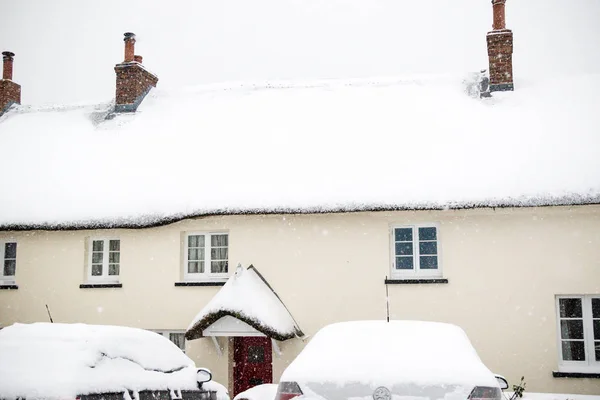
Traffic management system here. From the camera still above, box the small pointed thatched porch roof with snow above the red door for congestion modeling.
[185,265,304,340]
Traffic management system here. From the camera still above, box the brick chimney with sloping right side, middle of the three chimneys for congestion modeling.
[115,32,158,112]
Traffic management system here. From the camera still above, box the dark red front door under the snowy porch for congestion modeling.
[233,337,273,396]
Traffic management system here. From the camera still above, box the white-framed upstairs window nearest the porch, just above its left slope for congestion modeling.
[184,232,229,281]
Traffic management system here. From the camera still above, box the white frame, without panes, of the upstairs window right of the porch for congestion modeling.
[390,222,443,279]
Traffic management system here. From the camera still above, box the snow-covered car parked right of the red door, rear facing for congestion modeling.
[275,321,506,400]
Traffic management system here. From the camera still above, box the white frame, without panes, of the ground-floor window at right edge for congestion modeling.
[555,294,600,373]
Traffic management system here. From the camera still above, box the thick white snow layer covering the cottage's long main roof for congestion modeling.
[0,74,600,229]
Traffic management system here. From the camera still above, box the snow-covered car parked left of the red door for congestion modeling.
[0,323,229,400]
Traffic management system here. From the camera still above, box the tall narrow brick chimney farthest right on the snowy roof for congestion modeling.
[487,0,514,92]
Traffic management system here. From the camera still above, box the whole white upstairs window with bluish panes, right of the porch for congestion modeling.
[391,224,442,279]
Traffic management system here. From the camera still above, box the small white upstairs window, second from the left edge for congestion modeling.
[88,238,121,282]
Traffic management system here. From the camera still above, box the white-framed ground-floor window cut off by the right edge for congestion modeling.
[556,295,600,373]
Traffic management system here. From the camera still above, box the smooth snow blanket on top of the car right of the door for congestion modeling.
[281,321,497,388]
